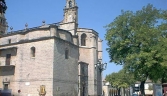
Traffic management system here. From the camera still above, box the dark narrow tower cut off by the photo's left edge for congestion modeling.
[0,0,7,34]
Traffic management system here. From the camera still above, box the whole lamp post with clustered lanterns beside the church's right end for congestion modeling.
[95,59,107,95]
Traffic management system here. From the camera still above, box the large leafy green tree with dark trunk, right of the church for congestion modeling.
[105,4,167,95]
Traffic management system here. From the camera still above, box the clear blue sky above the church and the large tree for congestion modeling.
[5,0,167,77]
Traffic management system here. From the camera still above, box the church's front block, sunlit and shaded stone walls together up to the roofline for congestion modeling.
[0,27,79,96]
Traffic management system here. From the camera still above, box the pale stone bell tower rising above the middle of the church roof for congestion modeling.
[60,0,78,35]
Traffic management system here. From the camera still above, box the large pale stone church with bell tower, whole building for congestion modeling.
[0,0,102,96]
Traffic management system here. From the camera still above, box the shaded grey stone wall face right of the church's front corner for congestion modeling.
[53,39,79,96]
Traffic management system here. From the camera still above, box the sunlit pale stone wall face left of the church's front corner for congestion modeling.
[0,39,54,96]
